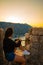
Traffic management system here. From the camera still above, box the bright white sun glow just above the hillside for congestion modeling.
[5,16,23,23]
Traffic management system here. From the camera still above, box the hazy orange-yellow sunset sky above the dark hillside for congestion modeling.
[0,0,43,27]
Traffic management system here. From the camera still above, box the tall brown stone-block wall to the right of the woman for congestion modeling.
[29,28,43,65]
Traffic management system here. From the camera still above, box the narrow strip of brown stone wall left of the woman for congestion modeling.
[0,28,4,65]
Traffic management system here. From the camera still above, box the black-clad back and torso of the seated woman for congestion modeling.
[3,38,15,53]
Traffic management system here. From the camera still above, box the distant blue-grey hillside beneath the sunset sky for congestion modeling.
[0,22,31,37]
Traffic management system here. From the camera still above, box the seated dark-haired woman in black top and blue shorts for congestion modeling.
[3,28,26,65]
